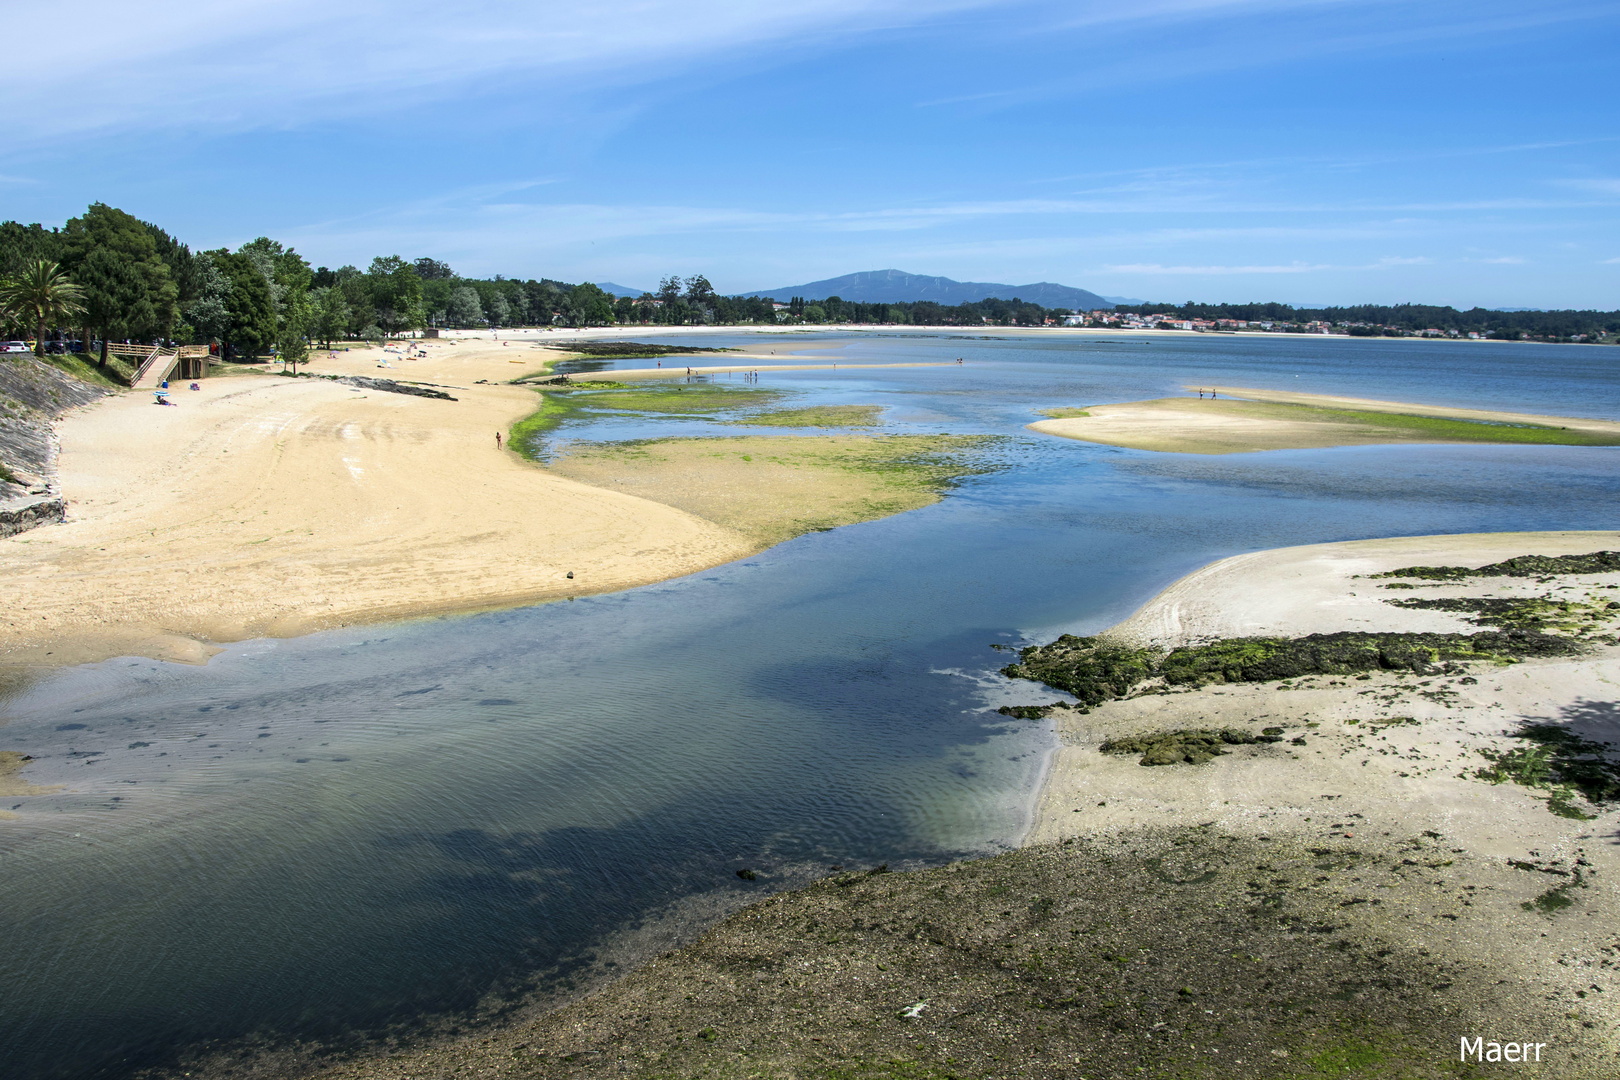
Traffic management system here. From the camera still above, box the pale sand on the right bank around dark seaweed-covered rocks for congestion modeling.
[1027,533,1620,1055]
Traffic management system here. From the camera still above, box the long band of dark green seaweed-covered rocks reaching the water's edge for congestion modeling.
[1001,630,1584,706]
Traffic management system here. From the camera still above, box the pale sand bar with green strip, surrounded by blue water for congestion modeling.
[1029,387,1620,453]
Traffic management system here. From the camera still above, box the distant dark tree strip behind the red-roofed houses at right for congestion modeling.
[1115,301,1620,342]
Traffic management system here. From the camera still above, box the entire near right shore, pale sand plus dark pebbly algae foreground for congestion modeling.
[281,531,1620,1080]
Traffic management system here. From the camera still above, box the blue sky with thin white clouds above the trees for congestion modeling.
[0,0,1620,309]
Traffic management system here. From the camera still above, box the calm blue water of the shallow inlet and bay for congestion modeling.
[0,334,1620,1078]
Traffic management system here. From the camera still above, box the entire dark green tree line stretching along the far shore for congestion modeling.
[0,202,1620,372]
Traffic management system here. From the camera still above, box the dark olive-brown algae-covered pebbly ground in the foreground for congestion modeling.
[309,827,1607,1080]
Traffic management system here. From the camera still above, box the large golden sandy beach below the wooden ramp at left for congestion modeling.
[0,342,755,665]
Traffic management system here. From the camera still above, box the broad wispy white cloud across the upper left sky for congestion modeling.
[0,0,1008,144]
